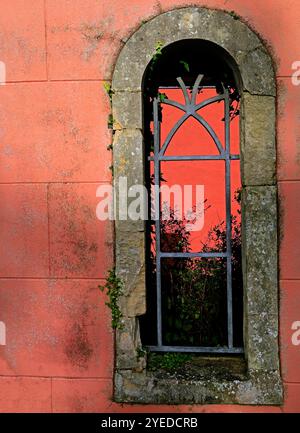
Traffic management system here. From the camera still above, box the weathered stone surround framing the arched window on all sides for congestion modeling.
[112,7,283,405]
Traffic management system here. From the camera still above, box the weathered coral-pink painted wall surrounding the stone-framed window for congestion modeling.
[0,0,300,412]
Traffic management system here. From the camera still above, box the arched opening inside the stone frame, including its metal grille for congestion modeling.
[141,40,243,354]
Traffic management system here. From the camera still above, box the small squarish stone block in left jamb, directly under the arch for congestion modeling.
[112,92,143,130]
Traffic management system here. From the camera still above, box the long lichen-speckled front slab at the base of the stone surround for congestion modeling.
[115,370,282,405]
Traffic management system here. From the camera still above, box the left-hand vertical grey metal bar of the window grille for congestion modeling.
[153,98,162,347]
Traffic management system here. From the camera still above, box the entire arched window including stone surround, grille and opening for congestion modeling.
[112,7,282,404]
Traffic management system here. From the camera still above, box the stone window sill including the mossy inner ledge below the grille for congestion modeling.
[115,357,282,405]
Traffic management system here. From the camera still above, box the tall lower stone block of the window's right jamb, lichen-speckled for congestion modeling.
[242,186,279,378]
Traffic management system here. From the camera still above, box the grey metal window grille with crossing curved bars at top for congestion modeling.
[148,75,243,354]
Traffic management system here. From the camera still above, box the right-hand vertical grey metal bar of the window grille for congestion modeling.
[224,90,233,348]
